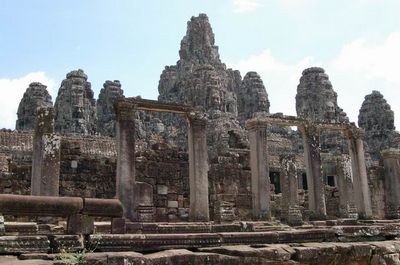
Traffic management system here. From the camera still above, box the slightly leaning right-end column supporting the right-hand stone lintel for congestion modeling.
[346,127,372,218]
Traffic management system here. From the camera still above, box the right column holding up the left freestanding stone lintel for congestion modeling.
[188,112,210,222]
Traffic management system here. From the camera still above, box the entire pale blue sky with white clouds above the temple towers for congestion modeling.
[0,0,400,129]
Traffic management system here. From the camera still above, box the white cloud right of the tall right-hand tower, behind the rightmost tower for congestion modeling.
[327,32,400,130]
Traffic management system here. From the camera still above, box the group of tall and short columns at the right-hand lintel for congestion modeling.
[247,120,374,223]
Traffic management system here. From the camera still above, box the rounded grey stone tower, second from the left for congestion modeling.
[55,69,97,134]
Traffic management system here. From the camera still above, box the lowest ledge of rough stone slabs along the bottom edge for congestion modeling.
[12,241,400,265]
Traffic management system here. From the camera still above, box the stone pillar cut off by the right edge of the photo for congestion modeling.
[382,148,400,219]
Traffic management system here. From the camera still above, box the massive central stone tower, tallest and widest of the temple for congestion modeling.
[158,14,245,154]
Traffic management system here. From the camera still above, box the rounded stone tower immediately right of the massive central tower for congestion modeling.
[237,72,270,123]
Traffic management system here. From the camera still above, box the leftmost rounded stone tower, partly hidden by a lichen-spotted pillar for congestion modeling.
[15,82,53,131]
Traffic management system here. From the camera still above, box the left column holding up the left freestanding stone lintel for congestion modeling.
[116,102,137,221]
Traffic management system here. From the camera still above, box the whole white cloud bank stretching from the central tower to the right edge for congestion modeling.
[229,32,400,130]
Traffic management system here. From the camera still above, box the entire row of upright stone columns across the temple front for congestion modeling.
[27,102,394,221]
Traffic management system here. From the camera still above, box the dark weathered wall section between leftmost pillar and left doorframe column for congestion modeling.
[60,137,116,199]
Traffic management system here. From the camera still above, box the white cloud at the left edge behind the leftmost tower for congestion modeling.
[0,72,54,129]
